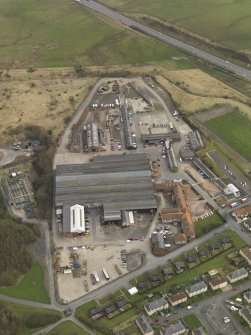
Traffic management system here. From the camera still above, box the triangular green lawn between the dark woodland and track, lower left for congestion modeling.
[0,263,50,303]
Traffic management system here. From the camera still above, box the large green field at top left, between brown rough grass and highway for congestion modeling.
[0,0,193,68]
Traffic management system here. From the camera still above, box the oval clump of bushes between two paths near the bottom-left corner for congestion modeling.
[23,312,60,329]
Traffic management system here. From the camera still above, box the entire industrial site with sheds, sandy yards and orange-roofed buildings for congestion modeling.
[53,76,251,303]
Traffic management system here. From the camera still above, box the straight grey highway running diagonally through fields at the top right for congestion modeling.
[79,0,251,80]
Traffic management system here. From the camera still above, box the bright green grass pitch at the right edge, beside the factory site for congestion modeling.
[205,112,251,160]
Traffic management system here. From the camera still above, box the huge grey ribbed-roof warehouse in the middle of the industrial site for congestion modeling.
[55,154,157,234]
